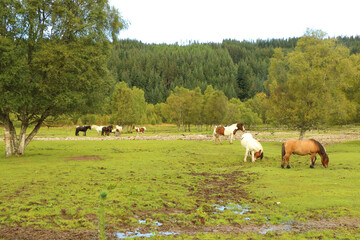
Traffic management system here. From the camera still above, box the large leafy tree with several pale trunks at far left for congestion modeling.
[0,0,124,156]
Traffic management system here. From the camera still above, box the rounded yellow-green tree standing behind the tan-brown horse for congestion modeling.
[266,31,354,138]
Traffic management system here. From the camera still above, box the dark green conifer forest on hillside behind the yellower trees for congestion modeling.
[110,37,360,104]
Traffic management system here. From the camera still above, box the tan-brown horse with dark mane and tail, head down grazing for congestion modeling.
[281,139,329,168]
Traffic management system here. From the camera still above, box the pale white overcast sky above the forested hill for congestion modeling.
[110,0,360,44]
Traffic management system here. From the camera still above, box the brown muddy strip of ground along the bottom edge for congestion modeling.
[0,217,360,240]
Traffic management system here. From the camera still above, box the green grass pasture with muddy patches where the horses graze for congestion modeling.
[0,128,360,239]
